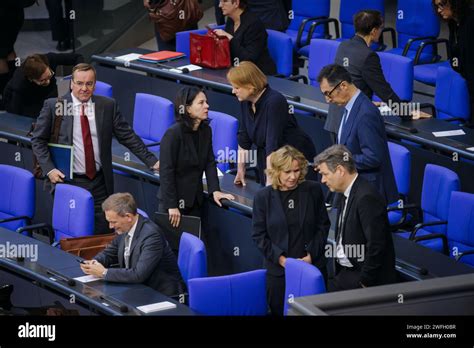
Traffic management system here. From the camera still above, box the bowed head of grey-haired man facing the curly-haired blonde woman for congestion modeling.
[314,145,357,192]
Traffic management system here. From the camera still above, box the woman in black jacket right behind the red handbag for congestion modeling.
[214,0,277,75]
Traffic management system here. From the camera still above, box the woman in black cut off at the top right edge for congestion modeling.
[432,0,474,128]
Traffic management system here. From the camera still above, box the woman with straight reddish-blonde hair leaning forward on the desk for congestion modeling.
[227,62,316,186]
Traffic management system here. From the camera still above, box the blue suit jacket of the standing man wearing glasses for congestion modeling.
[341,93,399,204]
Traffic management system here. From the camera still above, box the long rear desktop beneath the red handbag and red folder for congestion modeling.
[92,49,474,160]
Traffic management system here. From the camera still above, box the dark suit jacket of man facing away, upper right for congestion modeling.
[324,35,401,133]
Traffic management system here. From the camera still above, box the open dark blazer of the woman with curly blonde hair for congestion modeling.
[252,181,331,276]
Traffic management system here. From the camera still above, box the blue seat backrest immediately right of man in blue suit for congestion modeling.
[388,141,411,196]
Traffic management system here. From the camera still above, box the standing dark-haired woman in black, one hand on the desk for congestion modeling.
[158,87,234,227]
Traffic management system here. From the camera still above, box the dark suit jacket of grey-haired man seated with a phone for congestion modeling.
[94,216,185,296]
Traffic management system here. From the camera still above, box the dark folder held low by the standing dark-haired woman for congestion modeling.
[155,212,201,250]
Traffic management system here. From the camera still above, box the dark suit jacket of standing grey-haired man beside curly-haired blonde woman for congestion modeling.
[336,175,396,286]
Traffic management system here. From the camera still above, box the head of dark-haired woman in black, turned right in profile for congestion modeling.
[174,86,209,129]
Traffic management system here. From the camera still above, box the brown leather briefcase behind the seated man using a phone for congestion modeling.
[59,233,117,260]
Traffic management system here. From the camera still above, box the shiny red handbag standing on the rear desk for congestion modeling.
[189,30,230,69]
